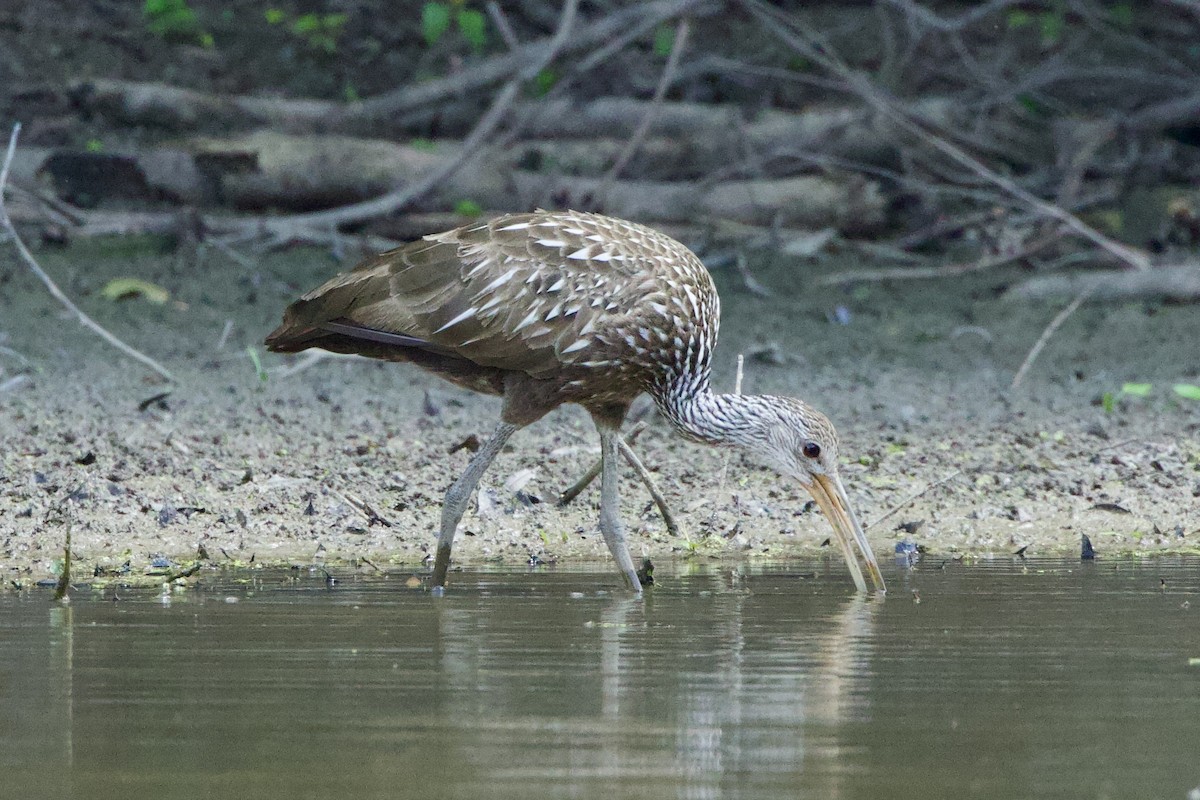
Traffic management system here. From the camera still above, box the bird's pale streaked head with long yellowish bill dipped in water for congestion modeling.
[748,397,884,591]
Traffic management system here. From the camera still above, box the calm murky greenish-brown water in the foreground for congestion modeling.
[0,558,1200,800]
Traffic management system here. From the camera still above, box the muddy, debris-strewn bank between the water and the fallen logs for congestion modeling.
[0,237,1200,579]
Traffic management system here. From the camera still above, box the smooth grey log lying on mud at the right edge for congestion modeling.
[1004,261,1200,302]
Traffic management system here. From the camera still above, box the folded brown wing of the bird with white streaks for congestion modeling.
[269,212,715,375]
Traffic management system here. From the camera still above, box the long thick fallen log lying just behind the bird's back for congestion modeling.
[23,131,884,233]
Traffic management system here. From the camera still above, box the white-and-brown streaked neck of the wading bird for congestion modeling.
[655,374,760,447]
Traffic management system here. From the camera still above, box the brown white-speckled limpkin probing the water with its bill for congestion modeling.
[266,211,883,591]
